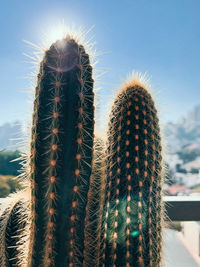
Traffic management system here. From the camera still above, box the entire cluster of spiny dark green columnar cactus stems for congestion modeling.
[0,29,164,267]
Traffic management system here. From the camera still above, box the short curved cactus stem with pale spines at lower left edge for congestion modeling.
[0,191,29,267]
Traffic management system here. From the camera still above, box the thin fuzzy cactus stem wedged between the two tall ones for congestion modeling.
[83,138,105,267]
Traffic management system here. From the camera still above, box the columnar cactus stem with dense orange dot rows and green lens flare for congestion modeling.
[102,78,163,267]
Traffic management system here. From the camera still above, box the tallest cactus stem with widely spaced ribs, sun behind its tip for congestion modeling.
[28,36,94,267]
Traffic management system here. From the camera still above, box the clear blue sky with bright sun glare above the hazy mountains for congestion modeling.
[0,0,200,125]
